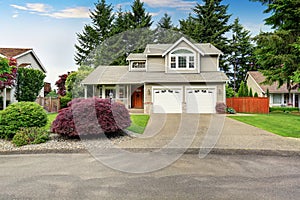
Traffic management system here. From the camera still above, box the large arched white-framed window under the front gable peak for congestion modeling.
[170,49,195,69]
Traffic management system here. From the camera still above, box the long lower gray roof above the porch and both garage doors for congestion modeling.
[82,66,228,85]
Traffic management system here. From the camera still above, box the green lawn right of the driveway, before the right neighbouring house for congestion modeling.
[230,113,300,138]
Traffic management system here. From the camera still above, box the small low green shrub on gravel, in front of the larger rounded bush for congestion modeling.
[12,127,49,146]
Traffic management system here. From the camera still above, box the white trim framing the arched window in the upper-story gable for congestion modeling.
[168,47,197,70]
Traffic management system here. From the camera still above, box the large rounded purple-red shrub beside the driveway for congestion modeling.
[51,97,131,137]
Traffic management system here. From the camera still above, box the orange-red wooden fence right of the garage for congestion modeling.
[226,97,269,114]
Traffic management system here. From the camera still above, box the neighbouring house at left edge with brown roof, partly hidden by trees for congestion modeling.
[0,48,46,103]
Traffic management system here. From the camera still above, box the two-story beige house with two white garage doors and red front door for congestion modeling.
[82,37,228,113]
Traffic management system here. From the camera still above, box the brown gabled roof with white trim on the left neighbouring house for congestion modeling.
[0,48,47,73]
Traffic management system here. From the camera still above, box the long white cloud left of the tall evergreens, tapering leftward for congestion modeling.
[43,7,90,19]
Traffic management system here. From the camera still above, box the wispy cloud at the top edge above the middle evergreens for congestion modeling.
[142,0,196,9]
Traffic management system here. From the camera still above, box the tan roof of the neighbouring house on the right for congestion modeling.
[246,71,299,93]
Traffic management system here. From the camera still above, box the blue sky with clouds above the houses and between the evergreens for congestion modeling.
[0,0,270,87]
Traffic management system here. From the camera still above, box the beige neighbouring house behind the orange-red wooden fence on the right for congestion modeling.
[246,71,300,107]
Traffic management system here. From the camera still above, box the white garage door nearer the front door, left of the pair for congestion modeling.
[153,89,182,113]
